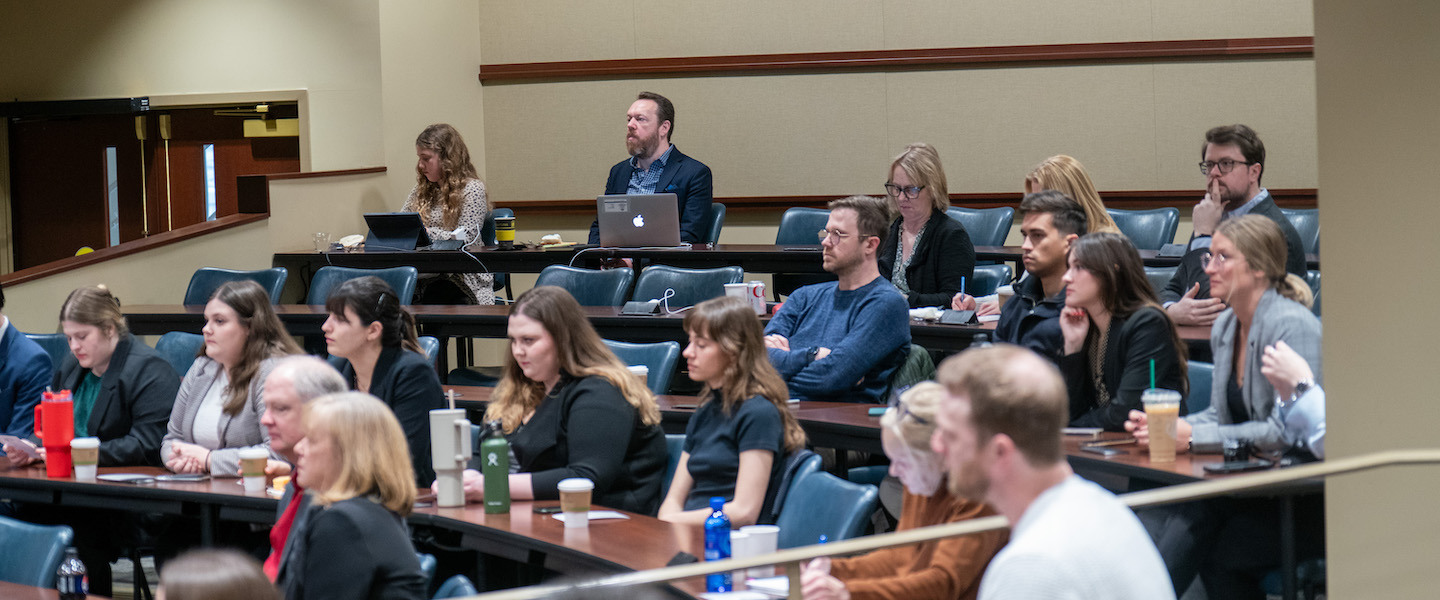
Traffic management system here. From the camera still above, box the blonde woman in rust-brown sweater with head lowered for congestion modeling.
[801,381,1008,600]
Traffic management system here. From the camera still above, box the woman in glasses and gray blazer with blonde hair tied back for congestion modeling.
[1126,214,1320,452]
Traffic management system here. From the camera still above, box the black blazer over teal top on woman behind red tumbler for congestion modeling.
[50,334,180,466]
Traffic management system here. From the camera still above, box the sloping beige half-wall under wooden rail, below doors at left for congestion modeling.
[4,223,271,332]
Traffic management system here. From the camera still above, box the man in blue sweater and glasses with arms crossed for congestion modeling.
[765,196,910,403]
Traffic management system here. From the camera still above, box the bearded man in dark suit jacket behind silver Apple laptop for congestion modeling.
[590,92,714,243]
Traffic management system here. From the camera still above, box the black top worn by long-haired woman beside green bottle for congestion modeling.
[469,373,667,515]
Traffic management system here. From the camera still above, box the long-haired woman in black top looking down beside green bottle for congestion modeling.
[465,285,665,515]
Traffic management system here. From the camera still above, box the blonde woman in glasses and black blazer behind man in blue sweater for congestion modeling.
[876,144,975,308]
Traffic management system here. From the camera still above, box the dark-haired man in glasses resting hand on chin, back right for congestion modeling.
[1159,125,1305,325]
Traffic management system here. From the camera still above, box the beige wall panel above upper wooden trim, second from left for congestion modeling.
[634,0,886,58]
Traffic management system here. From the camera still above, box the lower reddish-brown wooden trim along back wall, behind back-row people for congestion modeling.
[501,187,1318,216]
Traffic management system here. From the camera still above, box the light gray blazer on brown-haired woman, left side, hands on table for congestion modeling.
[160,357,284,478]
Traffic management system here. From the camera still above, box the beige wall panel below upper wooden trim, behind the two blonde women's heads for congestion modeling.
[880,65,1155,193]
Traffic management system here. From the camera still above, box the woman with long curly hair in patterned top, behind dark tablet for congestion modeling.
[400,122,495,304]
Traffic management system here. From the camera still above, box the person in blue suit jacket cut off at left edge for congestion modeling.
[0,276,55,439]
